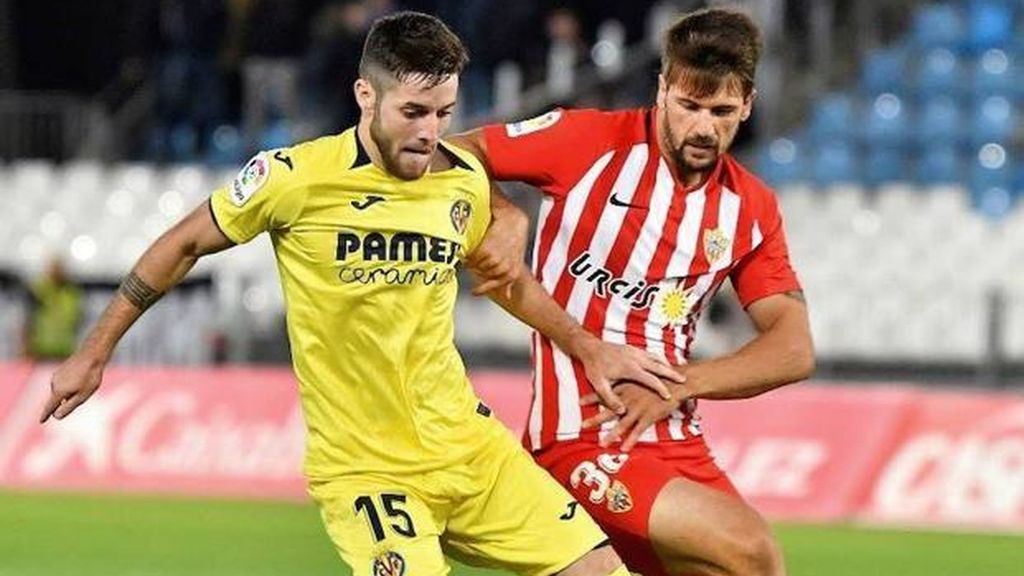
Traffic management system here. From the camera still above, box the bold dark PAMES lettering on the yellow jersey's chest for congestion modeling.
[335,232,460,264]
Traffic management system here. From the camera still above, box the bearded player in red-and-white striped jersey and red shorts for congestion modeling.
[457,9,814,576]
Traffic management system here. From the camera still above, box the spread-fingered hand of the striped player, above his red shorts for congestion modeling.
[581,382,686,452]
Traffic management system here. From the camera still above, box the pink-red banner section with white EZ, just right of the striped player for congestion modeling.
[699,384,916,520]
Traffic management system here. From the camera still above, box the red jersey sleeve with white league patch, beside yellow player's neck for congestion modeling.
[483,109,610,196]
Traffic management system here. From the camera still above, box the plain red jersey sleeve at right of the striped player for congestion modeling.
[730,193,801,307]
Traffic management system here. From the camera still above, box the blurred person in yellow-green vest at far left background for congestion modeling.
[25,258,83,360]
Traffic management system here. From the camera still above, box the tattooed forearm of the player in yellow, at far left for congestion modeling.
[80,231,199,363]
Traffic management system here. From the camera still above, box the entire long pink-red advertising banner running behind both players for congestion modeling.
[0,365,1024,531]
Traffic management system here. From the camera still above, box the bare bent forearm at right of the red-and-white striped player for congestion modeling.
[680,315,814,400]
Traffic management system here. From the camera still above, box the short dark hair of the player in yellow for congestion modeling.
[359,11,469,86]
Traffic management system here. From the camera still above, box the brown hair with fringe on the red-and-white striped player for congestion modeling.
[662,8,762,97]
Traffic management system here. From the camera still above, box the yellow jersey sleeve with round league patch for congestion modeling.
[210,152,300,244]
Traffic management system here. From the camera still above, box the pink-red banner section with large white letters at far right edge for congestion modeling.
[861,393,1024,531]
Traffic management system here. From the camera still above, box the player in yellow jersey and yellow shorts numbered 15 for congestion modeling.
[42,8,671,576]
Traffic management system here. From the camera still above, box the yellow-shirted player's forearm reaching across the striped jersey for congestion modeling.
[487,264,597,358]
